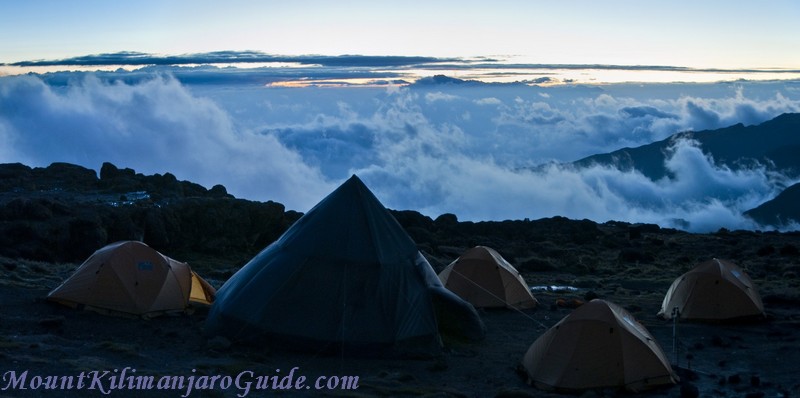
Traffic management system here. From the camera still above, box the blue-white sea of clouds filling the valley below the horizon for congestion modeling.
[0,71,800,231]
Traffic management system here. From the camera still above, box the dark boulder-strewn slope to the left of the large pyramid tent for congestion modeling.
[0,163,299,268]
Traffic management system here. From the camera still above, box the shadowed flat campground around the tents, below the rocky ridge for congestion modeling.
[0,224,800,397]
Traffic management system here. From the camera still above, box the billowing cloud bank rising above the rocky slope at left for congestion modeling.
[0,75,332,207]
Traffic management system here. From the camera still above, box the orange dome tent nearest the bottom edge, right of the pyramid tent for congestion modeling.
[522,299,678,392]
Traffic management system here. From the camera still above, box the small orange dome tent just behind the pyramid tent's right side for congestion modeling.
[439,246,538,309]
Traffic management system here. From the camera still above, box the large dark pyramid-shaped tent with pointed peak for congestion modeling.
[206,176,485,356]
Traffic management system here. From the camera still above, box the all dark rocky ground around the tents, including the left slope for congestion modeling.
[0,161,800,397]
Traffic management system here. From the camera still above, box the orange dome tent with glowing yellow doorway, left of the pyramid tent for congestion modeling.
[47,241,216,317]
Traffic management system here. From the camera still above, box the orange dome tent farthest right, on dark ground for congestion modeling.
[658,258,765,321]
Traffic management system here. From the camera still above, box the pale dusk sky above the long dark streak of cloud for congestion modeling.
[0,0,800,69]
